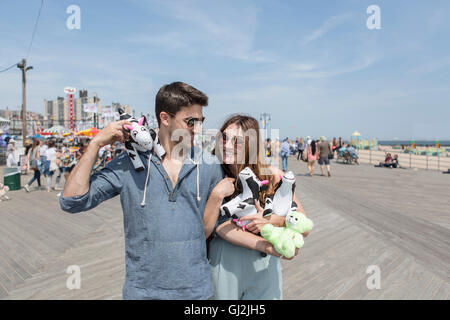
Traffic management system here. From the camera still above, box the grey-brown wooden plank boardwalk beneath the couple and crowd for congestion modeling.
[0,160,450,299]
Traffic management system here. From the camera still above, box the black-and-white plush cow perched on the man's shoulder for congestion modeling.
[118,108,165,171]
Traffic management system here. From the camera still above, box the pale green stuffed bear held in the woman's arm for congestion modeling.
[261,211,313,259]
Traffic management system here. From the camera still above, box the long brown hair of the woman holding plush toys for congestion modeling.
[213,114,277,202]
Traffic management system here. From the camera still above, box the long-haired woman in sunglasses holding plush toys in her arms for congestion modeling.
[204,115,307,300]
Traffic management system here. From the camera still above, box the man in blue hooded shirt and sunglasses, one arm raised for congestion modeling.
[60,82,223,299]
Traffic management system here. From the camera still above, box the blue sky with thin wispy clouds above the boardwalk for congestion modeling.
[0,0,450,139]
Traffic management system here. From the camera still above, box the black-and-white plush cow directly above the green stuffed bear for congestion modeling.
[264,171,298,217]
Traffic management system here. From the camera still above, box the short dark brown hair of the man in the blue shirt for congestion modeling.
[155,81,208,126]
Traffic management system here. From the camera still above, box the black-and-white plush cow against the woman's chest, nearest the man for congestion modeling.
[220,167,268,230]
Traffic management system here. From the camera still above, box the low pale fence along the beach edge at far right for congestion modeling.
[357,150,450,170]
